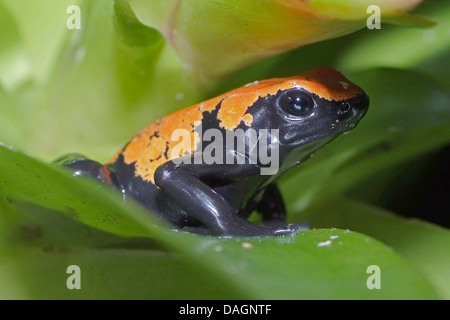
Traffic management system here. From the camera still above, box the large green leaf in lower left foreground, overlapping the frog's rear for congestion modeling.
[0,147,246,299]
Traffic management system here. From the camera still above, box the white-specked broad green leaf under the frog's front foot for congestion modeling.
[177,229,436,299]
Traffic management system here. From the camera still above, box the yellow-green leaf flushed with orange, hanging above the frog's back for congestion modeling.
[129,0,430,81]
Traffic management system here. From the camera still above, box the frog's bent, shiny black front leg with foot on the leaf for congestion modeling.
[155,158,298,236]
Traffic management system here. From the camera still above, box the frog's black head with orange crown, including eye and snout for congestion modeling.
[273,68,369,150]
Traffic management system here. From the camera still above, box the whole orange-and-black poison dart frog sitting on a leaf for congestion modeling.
[60,68,369,236]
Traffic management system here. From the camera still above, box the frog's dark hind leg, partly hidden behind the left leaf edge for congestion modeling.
[54,154,122,190]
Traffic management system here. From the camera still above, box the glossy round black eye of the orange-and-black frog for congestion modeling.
[277,89,314,117]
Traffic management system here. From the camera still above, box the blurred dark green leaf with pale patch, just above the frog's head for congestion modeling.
[214,1,450,94]
